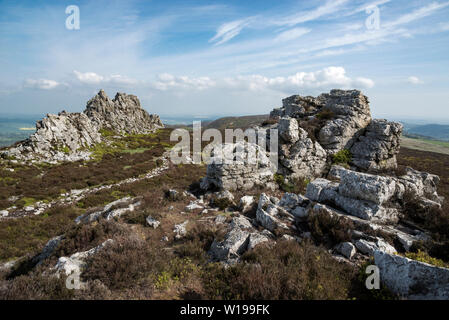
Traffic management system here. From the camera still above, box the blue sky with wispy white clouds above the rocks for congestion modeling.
[0,0,449,123]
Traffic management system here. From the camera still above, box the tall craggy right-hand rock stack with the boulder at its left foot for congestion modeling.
[203,90,402,190]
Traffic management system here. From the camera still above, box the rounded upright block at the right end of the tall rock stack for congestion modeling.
[350,119,402,171]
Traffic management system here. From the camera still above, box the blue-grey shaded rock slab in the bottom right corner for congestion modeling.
[374,251,449,300]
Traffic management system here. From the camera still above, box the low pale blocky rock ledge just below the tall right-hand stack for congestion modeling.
[305,167,441,223]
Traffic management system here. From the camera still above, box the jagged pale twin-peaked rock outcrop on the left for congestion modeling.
[0,90,163,162]
